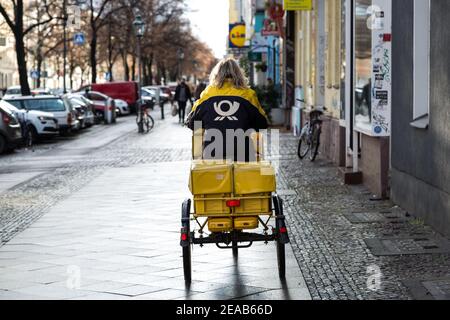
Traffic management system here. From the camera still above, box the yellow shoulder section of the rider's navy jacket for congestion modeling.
[192,84,267,118]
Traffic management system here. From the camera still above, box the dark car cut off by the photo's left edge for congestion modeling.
[0,101,22,154]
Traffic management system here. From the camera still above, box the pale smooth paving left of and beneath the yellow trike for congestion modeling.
[0,110,310,300]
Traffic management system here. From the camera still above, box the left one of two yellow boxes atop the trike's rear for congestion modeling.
[189,160,233,196]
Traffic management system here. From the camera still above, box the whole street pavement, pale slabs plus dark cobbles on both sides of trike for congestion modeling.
[0,110,450,299]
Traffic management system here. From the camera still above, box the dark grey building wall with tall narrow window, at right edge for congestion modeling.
[392,0,450,236]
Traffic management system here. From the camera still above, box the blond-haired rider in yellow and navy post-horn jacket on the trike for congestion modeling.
[187,58,268,162]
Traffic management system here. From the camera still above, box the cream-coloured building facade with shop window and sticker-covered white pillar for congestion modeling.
[286,0,391,198]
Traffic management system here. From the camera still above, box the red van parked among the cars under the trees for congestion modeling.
[78,81,139,112]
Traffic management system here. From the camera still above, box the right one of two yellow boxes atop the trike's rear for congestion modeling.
[234,161,276,195]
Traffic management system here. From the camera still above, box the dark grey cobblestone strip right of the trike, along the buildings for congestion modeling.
[279,135,450,299]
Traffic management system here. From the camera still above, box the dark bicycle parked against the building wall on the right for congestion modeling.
[297,99,327,162]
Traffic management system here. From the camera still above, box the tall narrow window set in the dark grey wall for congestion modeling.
[413,0,430,125]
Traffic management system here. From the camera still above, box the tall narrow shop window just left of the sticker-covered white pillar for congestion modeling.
[355,0,372,132]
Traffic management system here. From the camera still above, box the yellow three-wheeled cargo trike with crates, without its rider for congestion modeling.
[180,134,289,282]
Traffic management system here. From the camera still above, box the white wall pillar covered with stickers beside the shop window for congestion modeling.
[370,0,392,137]
